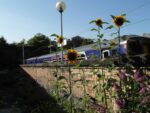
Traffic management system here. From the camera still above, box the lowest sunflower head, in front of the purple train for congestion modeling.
[65,49,78,64]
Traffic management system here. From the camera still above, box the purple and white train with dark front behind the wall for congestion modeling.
[26,35,150,65]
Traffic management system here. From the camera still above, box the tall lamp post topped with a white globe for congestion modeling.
[56,1,66,61]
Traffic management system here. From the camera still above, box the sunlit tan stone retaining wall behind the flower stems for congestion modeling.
[22,66,117,97]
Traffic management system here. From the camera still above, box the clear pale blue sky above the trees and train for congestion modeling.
[0,0,150,43]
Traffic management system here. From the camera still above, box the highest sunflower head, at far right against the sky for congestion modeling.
[113,16,126,27]
